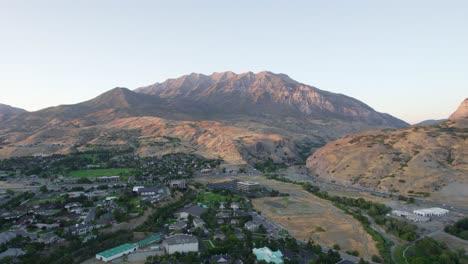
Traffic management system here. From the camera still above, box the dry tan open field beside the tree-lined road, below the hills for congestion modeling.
[239,176,379,259]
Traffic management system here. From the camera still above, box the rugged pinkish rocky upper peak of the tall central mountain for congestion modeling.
[135,71,408,127]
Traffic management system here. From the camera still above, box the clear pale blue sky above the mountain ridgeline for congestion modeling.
[0,0,468,123]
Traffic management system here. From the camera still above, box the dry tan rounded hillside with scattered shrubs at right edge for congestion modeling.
[307,100,468,206]
